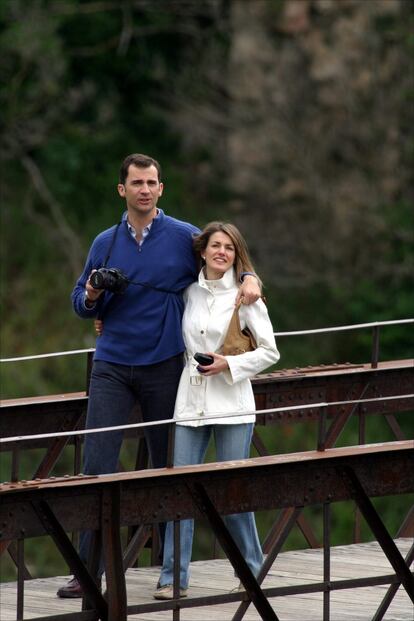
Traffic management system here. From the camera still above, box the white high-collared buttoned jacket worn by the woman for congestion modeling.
[174,268,280,427]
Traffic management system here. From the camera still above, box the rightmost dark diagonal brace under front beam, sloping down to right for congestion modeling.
[340,466,414,602]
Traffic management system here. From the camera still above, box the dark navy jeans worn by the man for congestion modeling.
[79,354,183,573]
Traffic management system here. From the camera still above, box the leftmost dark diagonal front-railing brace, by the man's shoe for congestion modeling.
[31,500,108,621]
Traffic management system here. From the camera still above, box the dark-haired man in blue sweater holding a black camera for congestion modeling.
[57,154,260,597]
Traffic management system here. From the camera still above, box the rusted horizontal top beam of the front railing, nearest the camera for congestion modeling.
[0,440,414,540]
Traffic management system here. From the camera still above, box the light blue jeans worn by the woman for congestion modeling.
[159,423,263,589]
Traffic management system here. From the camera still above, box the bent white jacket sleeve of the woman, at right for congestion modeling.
[224,300,280,384]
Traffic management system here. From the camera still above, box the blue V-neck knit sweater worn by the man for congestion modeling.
[72,209,199,365]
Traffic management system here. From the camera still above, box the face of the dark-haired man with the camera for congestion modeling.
[118,164,163,216]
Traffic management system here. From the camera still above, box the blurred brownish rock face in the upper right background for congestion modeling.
[173,0,414,286]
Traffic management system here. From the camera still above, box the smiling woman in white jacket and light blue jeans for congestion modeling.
[154,222,279,599]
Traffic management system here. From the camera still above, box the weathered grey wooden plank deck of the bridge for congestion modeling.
[0,538,414,621]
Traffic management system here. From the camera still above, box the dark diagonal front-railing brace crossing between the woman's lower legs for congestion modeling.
[190,483,278,621]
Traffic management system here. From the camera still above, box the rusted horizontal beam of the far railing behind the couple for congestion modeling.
[0,359,414,451]
